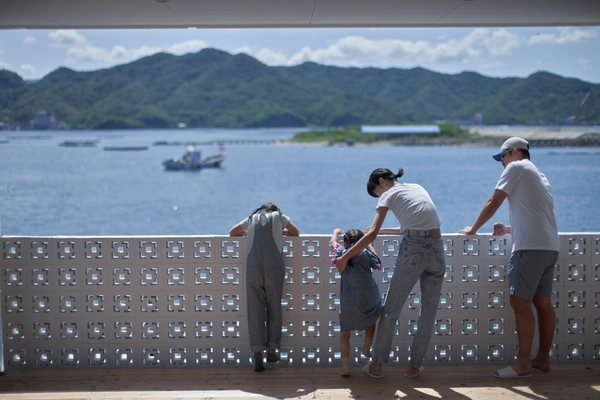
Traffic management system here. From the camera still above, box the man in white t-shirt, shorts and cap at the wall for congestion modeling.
[459,137,560,378]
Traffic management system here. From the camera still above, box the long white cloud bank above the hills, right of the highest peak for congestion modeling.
[244,29,521,66]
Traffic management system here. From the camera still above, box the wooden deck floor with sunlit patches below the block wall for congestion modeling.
[0,363,600,400]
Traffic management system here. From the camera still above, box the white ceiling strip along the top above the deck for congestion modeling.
[0,0,600,29]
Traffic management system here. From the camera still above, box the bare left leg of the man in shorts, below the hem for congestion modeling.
[510,295,535,375]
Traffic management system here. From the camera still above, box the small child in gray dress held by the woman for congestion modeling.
[329,228,383,376]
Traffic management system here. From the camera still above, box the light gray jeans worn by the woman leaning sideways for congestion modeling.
[373,236,446,368]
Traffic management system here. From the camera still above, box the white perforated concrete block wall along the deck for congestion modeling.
[0,233,600,371]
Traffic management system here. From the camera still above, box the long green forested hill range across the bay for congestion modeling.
[0,49,600,129]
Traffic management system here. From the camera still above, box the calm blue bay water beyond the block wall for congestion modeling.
[0,129,600,236]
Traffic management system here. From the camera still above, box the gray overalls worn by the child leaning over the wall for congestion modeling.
[246,213,285,351]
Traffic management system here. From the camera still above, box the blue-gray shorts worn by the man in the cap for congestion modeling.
[508,250,558,300]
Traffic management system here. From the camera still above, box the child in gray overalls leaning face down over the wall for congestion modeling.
[229,203,300,372]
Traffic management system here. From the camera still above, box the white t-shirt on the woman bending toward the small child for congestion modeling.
[376,182,440,232]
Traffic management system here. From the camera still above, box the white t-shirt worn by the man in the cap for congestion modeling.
[496,160,560,251]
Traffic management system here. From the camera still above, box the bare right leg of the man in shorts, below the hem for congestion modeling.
[531,296,556,372]
